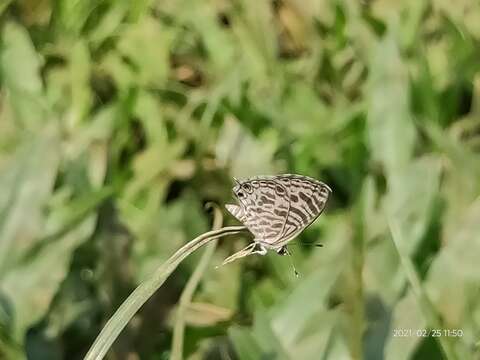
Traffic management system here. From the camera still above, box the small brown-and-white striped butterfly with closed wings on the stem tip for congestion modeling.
[222,174,332,265]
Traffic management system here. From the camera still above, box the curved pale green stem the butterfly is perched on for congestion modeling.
[84,226,246,360]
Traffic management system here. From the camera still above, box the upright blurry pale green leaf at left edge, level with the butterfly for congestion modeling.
[0,129,60,277]
